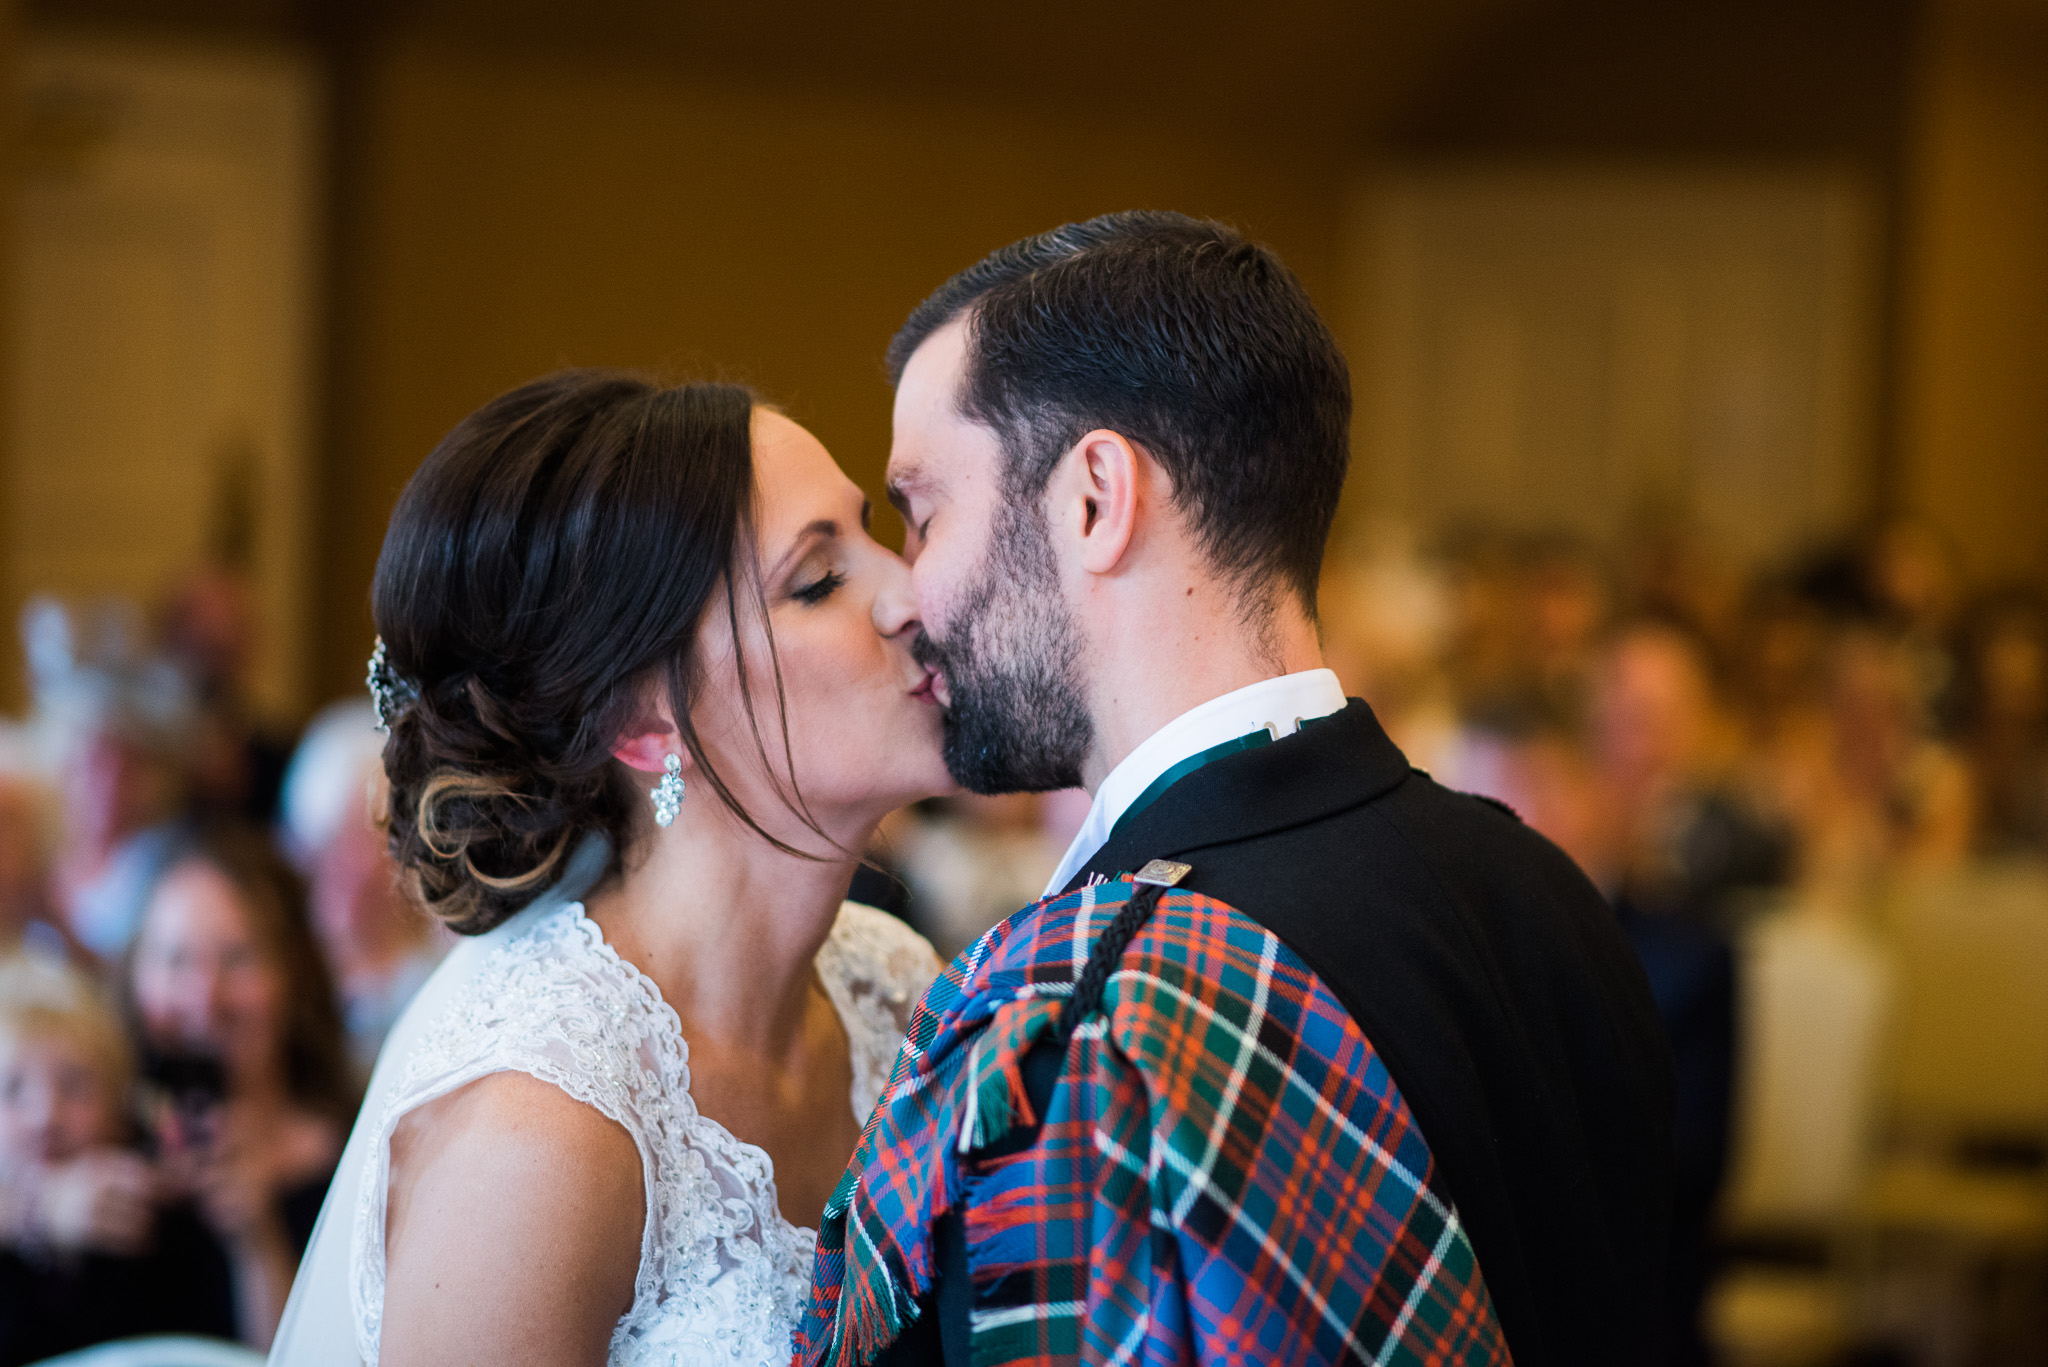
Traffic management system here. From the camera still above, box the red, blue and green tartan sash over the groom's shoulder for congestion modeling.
[797,881,1509,1367]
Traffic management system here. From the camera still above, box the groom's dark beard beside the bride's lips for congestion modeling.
[911,506,1096,793]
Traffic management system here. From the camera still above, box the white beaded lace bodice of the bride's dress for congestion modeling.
[350,902,938,1367]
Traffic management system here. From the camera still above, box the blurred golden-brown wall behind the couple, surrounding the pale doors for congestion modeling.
[0,0,2048,721]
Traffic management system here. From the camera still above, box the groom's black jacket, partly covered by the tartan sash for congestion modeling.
[905,699,1673,1367]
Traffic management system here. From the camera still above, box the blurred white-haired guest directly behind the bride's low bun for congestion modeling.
[279,701,449,1078]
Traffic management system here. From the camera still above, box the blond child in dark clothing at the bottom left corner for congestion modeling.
[0,969,233,1367]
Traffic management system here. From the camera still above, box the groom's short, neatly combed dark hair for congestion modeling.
[889,213,1352,615]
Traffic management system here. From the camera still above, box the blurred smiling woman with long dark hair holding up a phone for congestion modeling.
[127,826,354,1347]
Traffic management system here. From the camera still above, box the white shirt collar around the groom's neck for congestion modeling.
[1044,670,1343,898]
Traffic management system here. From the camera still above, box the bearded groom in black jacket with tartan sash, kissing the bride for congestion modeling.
[799,213,1671,1367]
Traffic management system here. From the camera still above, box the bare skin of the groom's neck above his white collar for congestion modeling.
[1081,582,1323,791]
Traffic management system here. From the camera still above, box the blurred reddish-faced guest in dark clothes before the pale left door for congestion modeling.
[156,562,291,824]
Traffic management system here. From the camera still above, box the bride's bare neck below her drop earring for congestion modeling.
[586,812,860,1053]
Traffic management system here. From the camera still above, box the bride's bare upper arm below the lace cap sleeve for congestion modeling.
[379,1072,645,1367]
